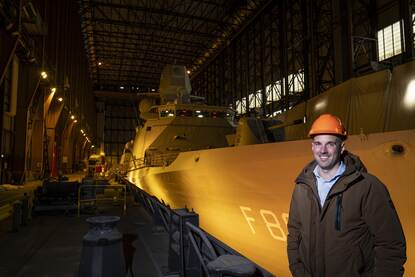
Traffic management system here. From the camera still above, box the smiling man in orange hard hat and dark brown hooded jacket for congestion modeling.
[287,114,406,277]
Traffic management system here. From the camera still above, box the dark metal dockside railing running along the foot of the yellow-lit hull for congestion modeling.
[126,181,274,277]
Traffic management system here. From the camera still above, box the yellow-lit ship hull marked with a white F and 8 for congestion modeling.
[128,130,415,277]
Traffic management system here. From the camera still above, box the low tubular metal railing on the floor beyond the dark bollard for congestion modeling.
[78,185,127,217]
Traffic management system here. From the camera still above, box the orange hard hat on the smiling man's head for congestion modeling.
[308,114,347,137]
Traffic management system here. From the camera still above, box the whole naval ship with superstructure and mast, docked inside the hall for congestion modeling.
[121,62,415,277]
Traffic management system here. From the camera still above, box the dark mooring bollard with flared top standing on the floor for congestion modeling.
[79,216,126,277]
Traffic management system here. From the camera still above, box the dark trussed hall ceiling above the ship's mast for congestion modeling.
[79,0,268,92]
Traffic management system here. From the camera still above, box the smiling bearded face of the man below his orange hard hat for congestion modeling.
[311,135,344,170]
